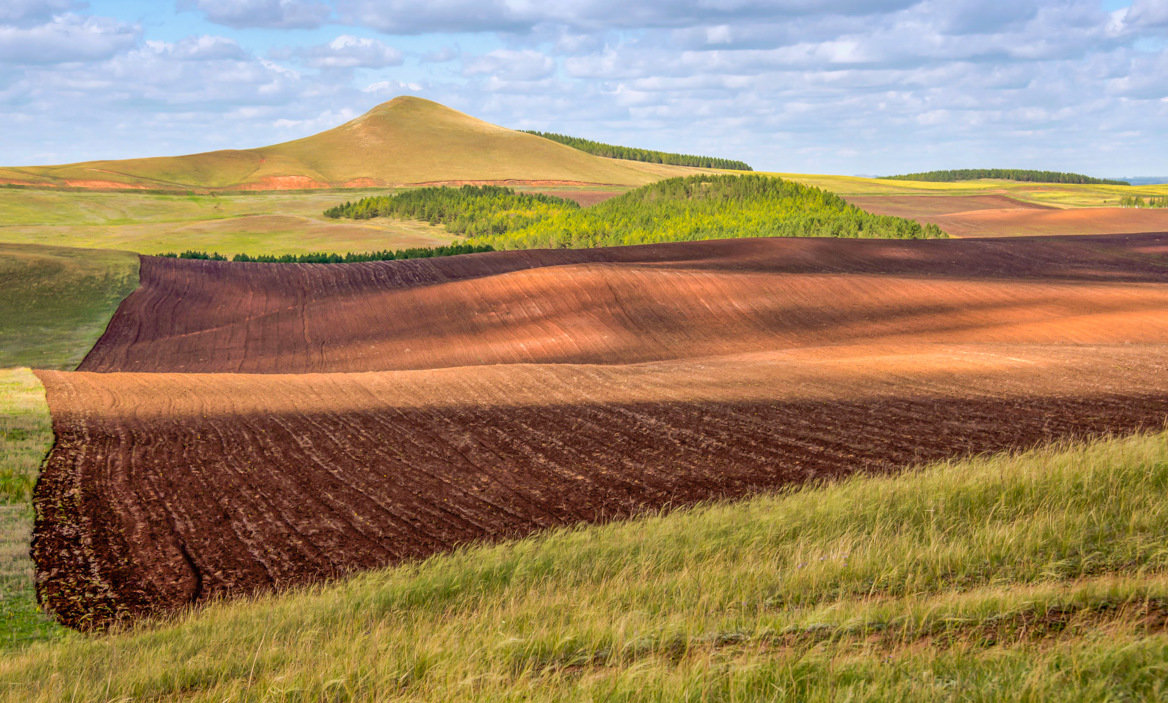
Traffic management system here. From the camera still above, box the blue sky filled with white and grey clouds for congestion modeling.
[0,0,1168,176]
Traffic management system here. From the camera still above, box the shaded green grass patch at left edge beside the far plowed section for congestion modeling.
[0,244,138,369]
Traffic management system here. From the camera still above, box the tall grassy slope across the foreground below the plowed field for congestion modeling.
[0,433,1168,701]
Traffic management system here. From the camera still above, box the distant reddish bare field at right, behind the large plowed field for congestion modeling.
[848,195,1168,237]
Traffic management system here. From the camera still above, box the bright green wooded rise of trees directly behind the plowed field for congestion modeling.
[324,175,945,249]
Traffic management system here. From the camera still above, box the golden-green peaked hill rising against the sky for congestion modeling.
[0,97,684,190]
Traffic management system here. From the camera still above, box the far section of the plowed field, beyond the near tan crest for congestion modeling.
[81,235,1168,374]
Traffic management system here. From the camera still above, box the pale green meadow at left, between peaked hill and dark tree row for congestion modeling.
[0,188,454,255]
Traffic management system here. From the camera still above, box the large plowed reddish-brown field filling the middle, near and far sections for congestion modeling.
[34,235,1168,627]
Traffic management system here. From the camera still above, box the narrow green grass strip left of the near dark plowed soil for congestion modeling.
[0,369,65,652]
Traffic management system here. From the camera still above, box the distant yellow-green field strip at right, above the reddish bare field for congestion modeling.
[771,173,1168,208]
